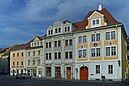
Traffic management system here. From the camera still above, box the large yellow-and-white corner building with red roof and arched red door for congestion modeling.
[74,5,129,80]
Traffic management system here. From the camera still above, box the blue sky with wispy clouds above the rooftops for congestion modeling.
[0,0,129,48]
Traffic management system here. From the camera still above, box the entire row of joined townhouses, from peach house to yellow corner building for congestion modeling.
[6,5,129,80]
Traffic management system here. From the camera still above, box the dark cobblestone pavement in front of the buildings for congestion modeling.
[0,75,129,86]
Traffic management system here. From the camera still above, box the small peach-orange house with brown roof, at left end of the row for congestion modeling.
[10,44,27,75]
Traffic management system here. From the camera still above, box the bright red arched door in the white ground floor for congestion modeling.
[80,67,88,80]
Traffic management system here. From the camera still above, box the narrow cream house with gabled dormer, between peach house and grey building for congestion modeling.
[26,36,44,77]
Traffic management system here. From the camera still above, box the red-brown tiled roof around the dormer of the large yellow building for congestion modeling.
[73,8,120,31]
